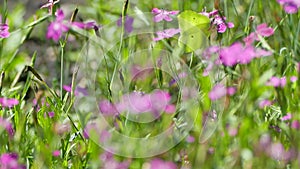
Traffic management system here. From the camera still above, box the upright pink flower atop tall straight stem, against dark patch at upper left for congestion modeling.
[47,9,69,41]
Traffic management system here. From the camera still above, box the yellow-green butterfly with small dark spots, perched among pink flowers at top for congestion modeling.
[178,10,210,52]
